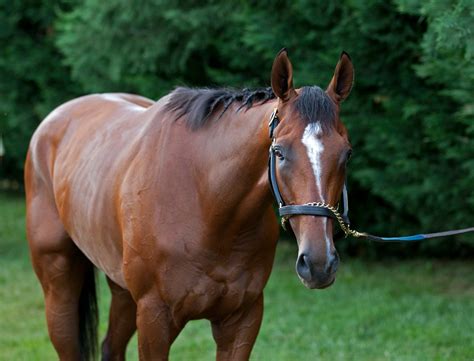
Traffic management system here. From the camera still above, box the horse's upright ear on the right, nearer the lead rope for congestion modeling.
[326,51,354,103]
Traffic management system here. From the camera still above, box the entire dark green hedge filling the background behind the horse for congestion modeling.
[0,0,474,255]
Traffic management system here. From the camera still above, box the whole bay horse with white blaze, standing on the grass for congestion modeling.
[25,49,354,360]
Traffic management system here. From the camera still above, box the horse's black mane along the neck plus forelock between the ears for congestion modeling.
[165,86,336,131]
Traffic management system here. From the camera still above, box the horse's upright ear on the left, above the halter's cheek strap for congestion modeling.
[272,48,296,102]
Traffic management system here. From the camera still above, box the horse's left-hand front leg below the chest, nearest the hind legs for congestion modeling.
[137,296,184,361]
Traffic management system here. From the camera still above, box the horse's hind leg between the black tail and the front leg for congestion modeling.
[102,277,137,361]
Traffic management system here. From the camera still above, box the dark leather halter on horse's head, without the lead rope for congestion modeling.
[268,108,350,229]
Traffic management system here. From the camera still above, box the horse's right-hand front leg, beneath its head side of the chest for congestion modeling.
[212,294,263,361]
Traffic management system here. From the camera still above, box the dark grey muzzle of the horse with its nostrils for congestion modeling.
[296,252,339,289]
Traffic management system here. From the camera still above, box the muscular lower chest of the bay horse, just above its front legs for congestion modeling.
[152,240,274,319]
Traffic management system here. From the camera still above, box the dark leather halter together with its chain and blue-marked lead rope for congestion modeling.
[268,108,474,242]
